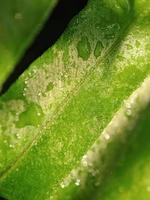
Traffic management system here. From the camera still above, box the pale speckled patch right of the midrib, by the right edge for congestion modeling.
[116,31,149,72]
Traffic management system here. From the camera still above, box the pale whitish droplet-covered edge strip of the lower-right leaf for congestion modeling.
[61,77,149,190]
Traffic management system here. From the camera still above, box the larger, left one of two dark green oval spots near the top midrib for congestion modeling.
[77,37,91,60]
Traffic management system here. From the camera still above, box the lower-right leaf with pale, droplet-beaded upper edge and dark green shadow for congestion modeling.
[54,78,150,200]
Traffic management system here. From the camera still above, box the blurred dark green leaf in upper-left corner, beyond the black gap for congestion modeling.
[0,0,57,86]
